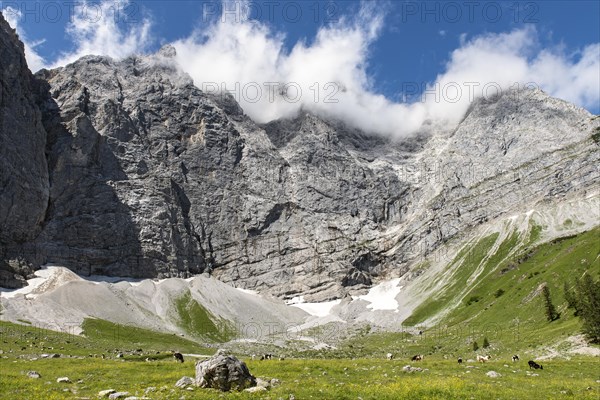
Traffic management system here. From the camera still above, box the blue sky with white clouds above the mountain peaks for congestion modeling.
[0,0,600,133]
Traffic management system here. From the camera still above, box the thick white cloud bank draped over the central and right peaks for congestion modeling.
[174,4,600,136]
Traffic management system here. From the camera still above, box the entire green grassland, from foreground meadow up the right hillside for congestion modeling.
[0,229,600,400]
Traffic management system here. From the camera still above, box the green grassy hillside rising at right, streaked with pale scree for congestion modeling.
[354,228,600,357]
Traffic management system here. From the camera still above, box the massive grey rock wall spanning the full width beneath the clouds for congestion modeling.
[0,14,600,300]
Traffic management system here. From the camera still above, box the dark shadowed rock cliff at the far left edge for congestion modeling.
[0,14,49,286]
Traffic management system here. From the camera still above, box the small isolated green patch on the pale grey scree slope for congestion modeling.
[175,291,235,342]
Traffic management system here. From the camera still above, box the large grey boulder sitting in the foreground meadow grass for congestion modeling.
[196,350,256,392]
